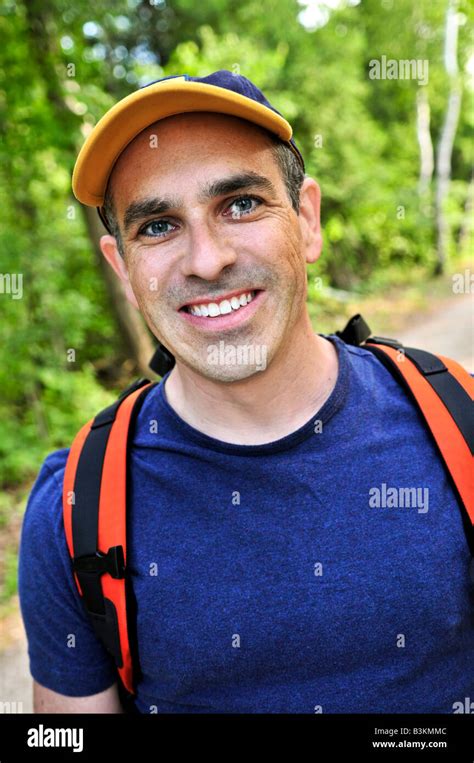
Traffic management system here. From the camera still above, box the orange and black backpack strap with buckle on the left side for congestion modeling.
[63,379,156,710]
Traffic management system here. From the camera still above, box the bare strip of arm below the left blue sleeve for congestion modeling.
[33,681,123,713]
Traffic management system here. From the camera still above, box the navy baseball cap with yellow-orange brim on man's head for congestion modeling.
[72,69,305,211]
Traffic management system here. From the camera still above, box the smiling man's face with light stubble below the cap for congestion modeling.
[103,113,320,382]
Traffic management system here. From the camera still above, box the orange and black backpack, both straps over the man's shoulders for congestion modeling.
[63,315,474,712]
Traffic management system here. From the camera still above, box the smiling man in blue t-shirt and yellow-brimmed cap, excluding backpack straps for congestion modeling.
[19,71,474,713]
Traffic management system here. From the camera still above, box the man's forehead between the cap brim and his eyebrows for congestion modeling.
[110,112,279,202]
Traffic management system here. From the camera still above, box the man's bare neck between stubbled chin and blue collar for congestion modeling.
[165,318,338,445]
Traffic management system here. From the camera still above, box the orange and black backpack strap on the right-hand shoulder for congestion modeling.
[336,315,474,556]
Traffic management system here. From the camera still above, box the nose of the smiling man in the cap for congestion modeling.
[181,220,237,281]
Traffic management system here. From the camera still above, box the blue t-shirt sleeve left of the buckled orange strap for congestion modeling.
[18,450,117,697]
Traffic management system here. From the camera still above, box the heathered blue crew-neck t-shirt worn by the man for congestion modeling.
[19,336,474,713]
